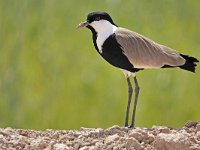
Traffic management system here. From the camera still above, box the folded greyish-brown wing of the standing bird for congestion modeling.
[115,28,185,68]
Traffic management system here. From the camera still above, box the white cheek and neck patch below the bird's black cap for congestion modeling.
[90,20,117,53]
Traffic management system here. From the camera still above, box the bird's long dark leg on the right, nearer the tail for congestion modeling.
[130,76,140,128]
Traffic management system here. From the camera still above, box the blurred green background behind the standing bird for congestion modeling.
[0,0,200,129]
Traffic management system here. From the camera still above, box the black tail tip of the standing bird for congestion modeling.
[179,54,199,72]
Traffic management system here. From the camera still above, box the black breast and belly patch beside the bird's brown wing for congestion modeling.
[100,34,140,72]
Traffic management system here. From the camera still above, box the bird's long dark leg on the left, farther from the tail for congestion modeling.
[124,77,133,127]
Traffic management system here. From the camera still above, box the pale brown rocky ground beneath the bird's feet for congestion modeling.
[0,122,200,150]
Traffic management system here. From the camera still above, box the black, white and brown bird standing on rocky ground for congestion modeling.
[76,11,199,128]
